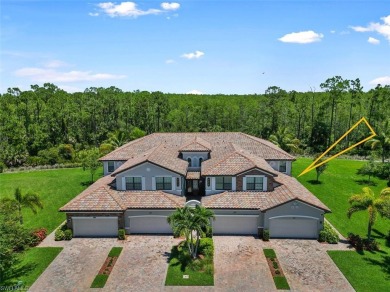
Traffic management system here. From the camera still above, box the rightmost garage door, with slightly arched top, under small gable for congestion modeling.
[269,217,318,238]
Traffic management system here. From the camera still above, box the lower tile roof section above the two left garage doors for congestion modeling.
[60,176,186,212]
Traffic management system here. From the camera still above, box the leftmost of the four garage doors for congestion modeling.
[72,217,118,237]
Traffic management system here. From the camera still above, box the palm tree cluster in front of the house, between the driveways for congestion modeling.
[167,206,214,259]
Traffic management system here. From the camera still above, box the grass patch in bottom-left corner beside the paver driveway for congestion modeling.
[0,247,62,288]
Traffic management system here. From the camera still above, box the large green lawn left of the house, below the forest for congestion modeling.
[0,168,102,233]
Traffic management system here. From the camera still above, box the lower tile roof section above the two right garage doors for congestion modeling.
[202,174,330,212]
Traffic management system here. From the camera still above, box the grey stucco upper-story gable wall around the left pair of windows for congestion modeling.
[116,162,185,195]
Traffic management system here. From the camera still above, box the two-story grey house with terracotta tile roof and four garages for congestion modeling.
[60,133,330,238]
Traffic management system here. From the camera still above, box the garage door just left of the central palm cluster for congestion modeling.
[129,216,172,234]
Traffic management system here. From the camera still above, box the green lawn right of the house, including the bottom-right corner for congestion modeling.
[293,158,390,291]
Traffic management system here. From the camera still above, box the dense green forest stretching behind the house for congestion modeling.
[0,76,390,167]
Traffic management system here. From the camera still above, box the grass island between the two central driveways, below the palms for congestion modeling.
[165,238,214,286]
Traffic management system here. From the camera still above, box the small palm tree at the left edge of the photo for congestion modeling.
[2,188,43,224]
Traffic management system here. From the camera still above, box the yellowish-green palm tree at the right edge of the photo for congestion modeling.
[347,187,390,240]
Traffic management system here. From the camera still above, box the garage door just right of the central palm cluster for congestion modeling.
[212,215,259,234]
